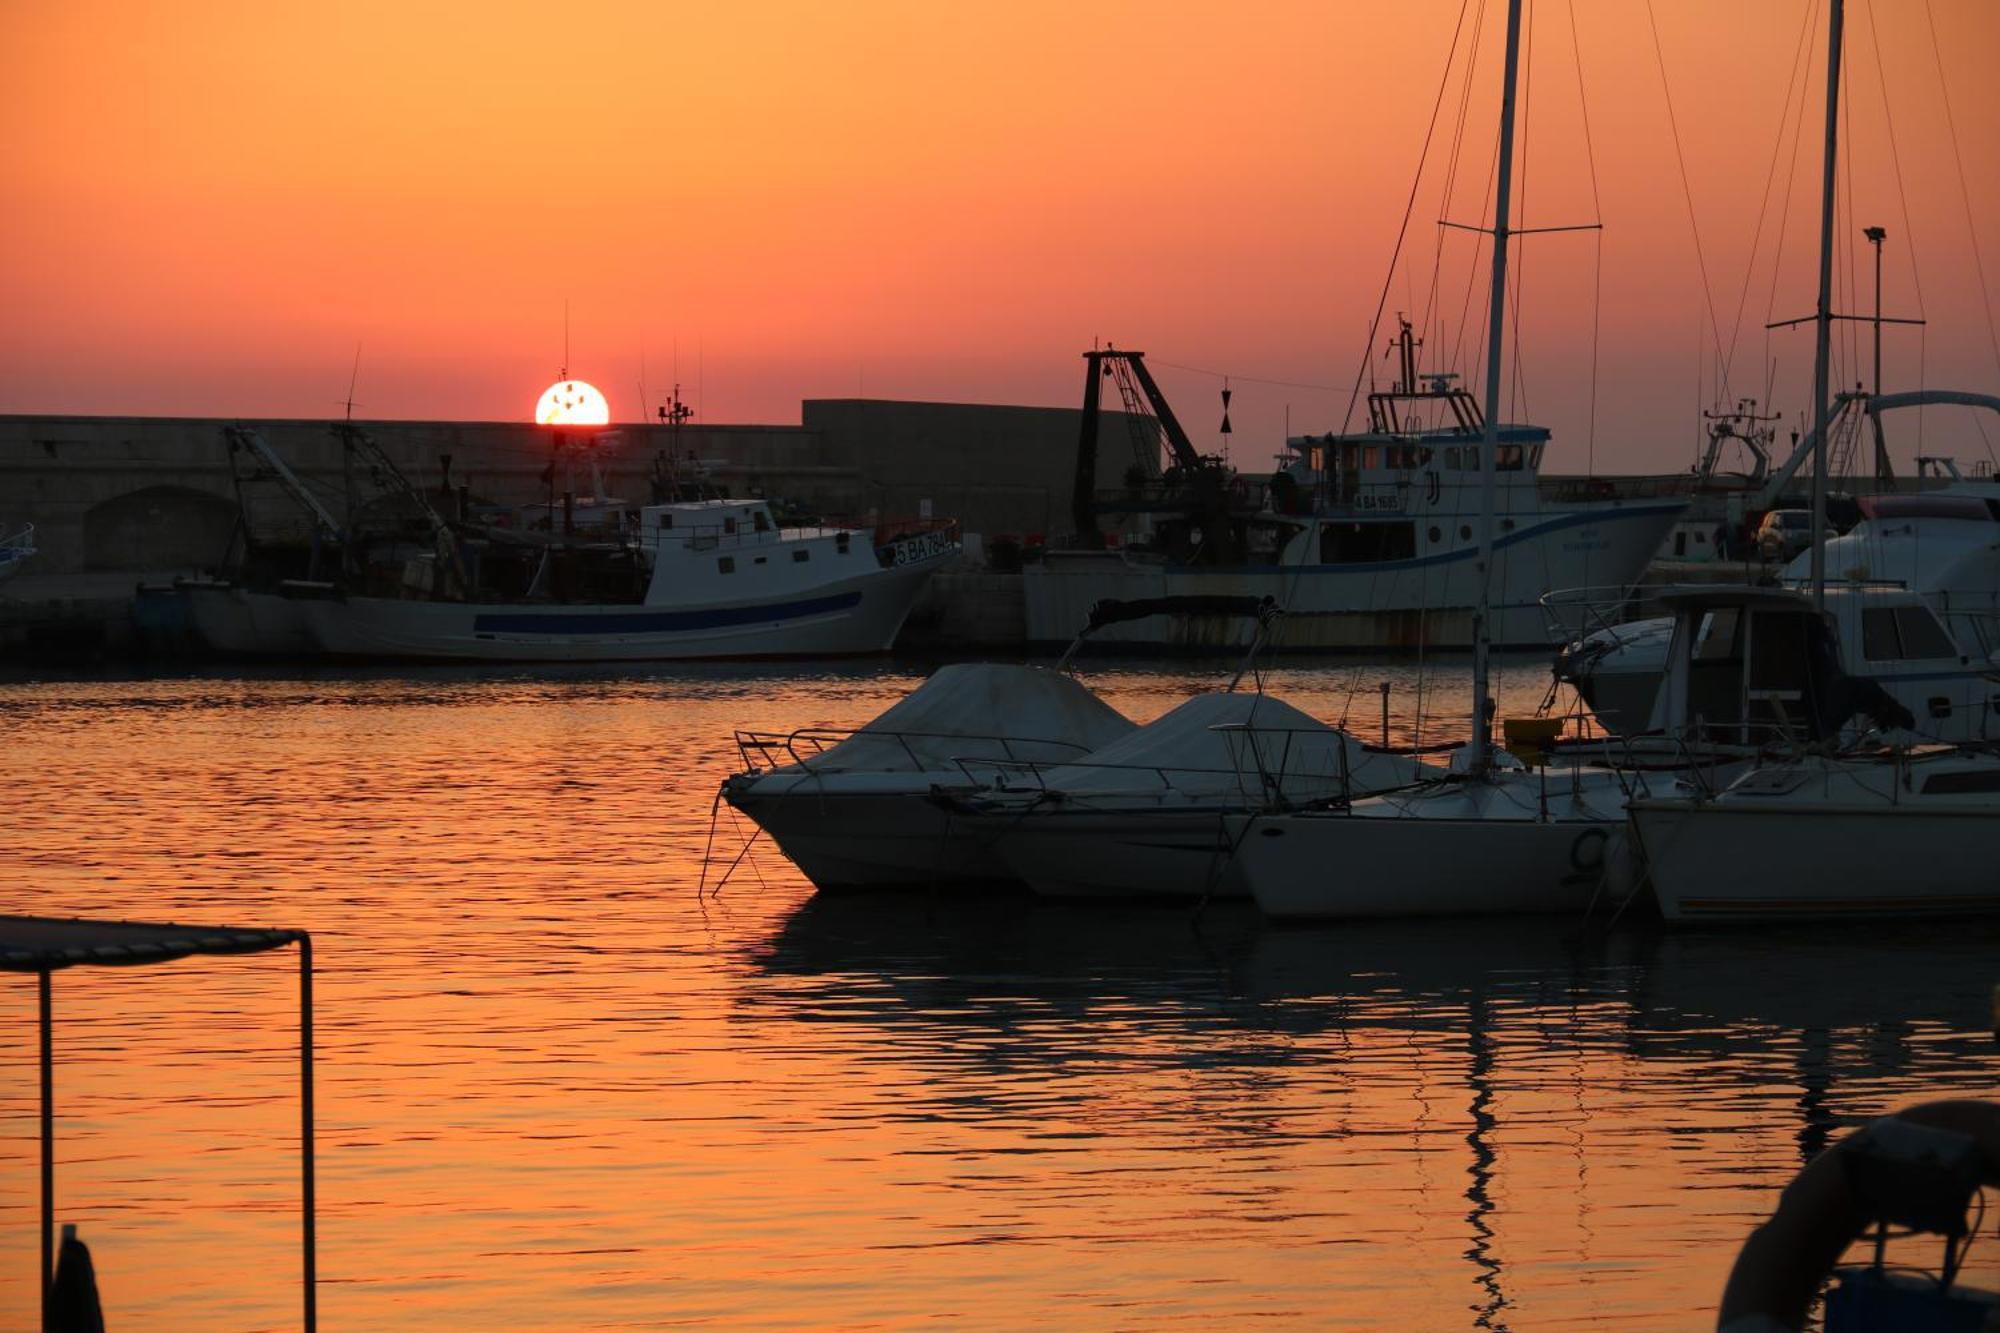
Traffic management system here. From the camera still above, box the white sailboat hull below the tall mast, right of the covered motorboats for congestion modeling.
[1236,815,1622,921]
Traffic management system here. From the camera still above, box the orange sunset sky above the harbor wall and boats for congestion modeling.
[0,0,2000,470]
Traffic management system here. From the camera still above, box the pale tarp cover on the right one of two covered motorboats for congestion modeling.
[1044,693,1426,803]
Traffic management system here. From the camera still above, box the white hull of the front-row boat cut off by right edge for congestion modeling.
[1630,792,2000,923]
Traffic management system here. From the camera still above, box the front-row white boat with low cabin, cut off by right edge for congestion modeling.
[1630,747,2000,923]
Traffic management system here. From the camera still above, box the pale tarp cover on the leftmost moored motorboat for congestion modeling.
[796,662,1136,773]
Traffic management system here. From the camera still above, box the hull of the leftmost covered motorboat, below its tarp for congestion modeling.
[722,779,1018,891]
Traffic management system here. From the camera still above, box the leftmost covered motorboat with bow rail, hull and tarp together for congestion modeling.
[722,662,1134,889]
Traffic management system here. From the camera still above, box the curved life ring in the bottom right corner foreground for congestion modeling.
[1716,1101,2000,1333]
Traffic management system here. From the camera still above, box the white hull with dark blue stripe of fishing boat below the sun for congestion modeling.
[300,562,936,662]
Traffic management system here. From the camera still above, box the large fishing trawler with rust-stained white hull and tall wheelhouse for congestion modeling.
[1022,322,1686,648]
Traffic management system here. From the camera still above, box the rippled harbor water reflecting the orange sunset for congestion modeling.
[0,662,2000,1329]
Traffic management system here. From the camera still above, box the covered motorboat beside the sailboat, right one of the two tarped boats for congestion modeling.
[940,691,1436,899]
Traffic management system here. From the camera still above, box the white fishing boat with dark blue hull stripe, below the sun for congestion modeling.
[288,500,958,662]
